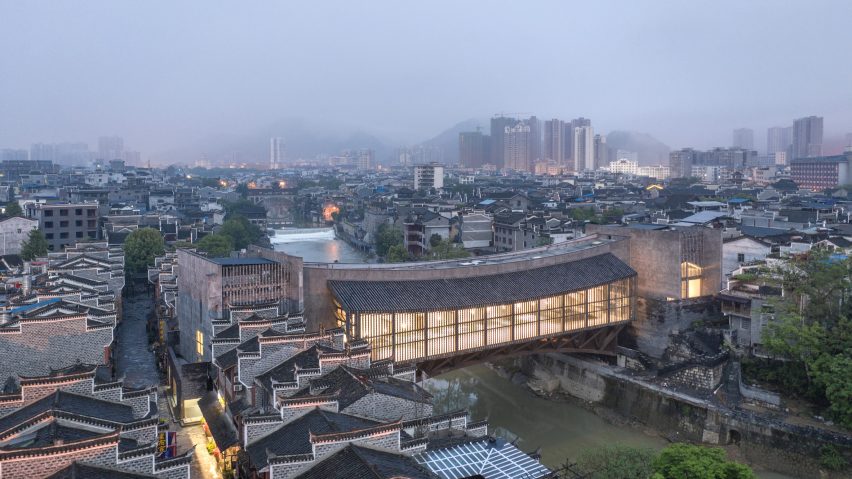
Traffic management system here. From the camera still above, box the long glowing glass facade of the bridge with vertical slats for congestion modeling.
[335,276,636,361]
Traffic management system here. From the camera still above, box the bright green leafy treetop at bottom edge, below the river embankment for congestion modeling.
[651,443,756,479]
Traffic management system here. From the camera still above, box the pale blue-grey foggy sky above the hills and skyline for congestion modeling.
[0,0,852,160]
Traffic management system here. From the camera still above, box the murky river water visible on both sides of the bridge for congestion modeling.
[271,228,793,479]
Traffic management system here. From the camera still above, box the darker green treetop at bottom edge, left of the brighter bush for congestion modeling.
[576,444,657,479]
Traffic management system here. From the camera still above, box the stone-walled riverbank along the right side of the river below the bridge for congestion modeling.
[510,354,852,479]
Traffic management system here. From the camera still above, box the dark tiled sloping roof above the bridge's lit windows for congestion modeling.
[328,253,636,311]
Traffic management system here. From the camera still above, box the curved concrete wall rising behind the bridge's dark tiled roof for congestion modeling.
[303,236,632,331]
